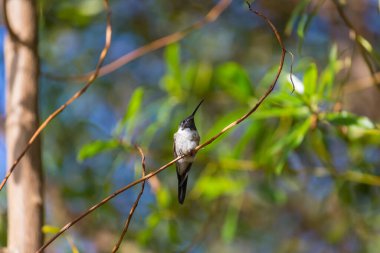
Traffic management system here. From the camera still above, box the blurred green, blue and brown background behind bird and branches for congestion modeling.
[0,0,380,253]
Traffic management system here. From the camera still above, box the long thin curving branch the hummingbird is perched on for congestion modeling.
[37,3,286,253]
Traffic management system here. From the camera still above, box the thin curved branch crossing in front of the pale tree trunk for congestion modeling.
[0,0,112,191]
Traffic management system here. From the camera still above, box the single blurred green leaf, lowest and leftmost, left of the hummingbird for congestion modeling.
[77,140,120,162]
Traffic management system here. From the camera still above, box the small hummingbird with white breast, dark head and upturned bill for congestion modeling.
[173,99,203,204]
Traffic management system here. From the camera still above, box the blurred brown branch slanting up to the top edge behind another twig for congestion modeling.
[45,0,231,81]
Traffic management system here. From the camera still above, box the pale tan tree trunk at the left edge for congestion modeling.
[4,0,43,253]
